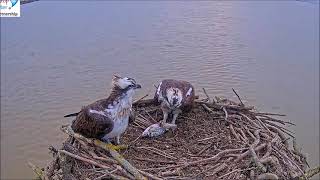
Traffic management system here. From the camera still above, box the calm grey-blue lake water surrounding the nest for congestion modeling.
[1,1,319,178]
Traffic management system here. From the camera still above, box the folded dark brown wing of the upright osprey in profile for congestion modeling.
[71,108,113,138]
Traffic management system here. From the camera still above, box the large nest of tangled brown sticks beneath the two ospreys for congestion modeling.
[31,91,319,180]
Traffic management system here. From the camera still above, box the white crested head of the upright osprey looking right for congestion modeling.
[112,75,141,91]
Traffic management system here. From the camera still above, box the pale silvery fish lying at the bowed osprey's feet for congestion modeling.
[142,121,177,137]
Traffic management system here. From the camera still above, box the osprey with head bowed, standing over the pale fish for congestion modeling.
[154,79,195,124]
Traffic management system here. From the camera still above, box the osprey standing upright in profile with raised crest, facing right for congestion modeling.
[64,75,141,144]
